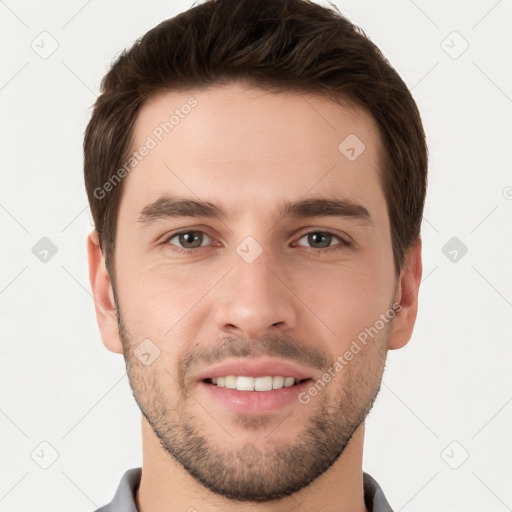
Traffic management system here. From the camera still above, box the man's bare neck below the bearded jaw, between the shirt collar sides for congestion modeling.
[136,417,366,512]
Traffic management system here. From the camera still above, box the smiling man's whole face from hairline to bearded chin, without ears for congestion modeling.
[115,84,397,500]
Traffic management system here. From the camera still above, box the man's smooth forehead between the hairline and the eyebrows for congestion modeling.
[121,83,383,220]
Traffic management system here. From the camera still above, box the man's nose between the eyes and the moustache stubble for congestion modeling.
[215,250,298,339]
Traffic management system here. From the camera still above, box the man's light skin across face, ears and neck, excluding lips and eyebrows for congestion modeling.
[88,83,422,512]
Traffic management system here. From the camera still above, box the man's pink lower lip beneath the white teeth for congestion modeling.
[199,379,311,414]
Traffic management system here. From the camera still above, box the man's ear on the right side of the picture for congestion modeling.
[389,238,423,350]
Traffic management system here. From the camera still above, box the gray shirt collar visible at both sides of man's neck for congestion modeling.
[95,468,393,512]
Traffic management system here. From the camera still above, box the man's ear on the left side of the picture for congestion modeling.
[87,230,123,354]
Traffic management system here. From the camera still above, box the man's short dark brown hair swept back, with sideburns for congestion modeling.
[84,0,428,278]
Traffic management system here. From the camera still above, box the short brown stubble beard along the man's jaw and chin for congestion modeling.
[118,315,389,502]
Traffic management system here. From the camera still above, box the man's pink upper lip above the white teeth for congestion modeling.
[197,358,311,380]
